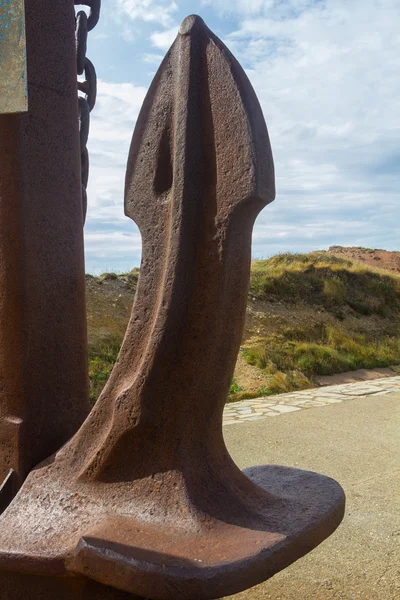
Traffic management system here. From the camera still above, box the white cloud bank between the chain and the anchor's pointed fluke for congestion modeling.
[85,79,147,272]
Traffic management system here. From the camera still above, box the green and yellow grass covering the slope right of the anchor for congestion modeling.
[238,252,400,399]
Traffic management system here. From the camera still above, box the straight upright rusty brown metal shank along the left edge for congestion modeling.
[0,0,89,504]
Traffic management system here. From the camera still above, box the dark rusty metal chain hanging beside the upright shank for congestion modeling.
[74,0,101,223]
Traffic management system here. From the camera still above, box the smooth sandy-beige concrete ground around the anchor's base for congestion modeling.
[224,392,400,600]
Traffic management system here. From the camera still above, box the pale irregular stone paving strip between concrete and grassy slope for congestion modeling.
[223,376,400,425]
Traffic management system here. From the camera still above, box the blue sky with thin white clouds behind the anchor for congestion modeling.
[77,0,400,274]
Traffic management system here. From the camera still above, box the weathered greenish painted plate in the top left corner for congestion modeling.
[0,0,28,114]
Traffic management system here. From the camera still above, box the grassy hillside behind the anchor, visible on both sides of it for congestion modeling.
[86,247,400,401]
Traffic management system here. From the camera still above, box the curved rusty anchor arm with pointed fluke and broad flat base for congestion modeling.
[0,16,344,600]
